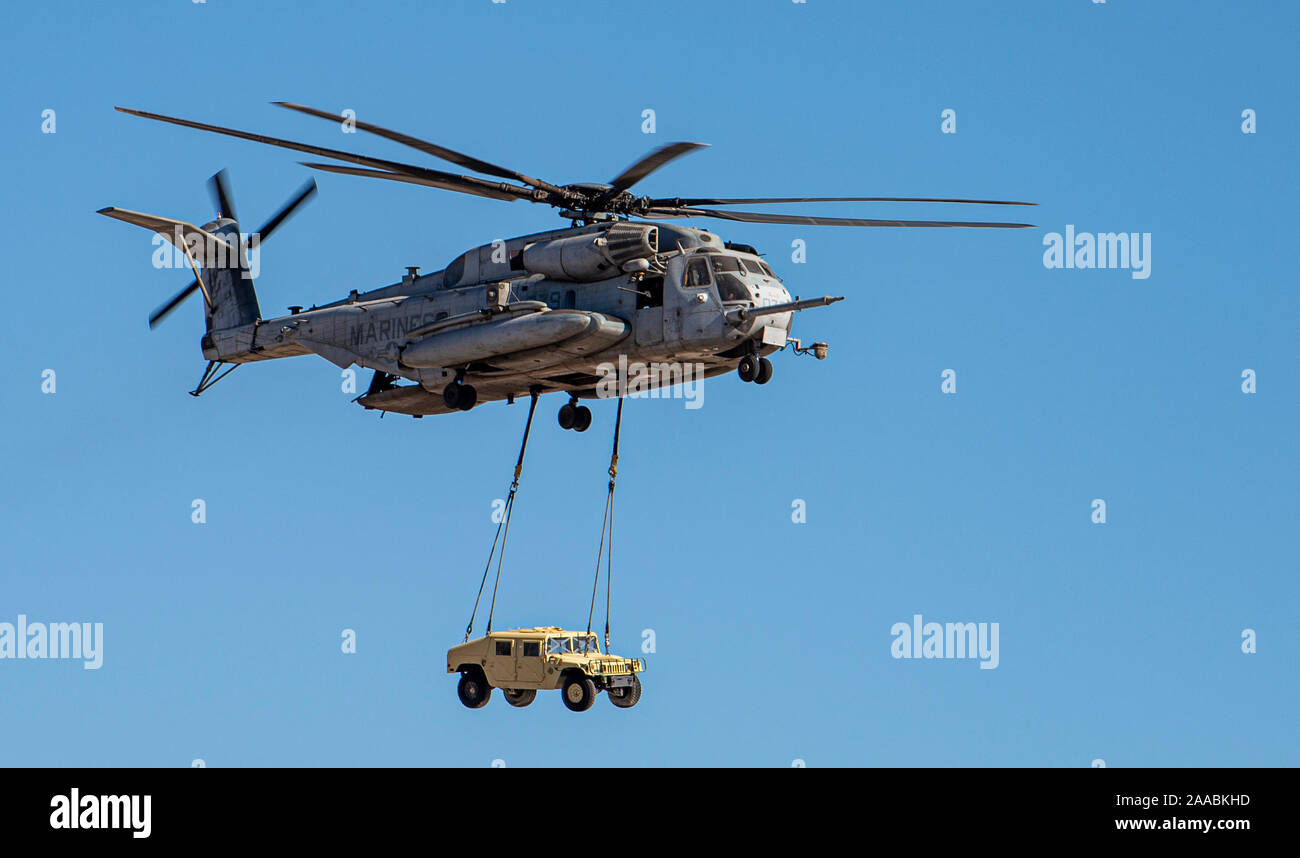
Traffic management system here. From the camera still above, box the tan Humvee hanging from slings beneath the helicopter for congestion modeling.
[447,625,646,712]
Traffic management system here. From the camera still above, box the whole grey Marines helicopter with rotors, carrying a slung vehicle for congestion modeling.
[100,101,1030,432]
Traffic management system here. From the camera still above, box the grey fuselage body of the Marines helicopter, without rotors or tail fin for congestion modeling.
[203,221,821,416]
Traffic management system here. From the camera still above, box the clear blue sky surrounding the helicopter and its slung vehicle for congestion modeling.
[0,0,1300,767]
